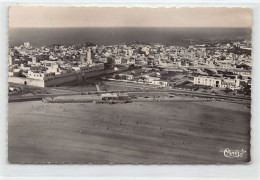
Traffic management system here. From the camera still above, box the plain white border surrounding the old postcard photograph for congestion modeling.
[0,0,260,180]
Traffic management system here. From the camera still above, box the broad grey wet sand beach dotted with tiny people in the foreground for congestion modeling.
[8,101,251,163]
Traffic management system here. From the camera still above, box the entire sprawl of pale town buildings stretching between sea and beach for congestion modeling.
[8,41,252,89]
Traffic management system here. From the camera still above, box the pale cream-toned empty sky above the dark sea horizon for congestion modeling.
[9,6,252,28]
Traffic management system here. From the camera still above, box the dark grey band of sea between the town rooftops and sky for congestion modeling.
[9,27,252,47]
